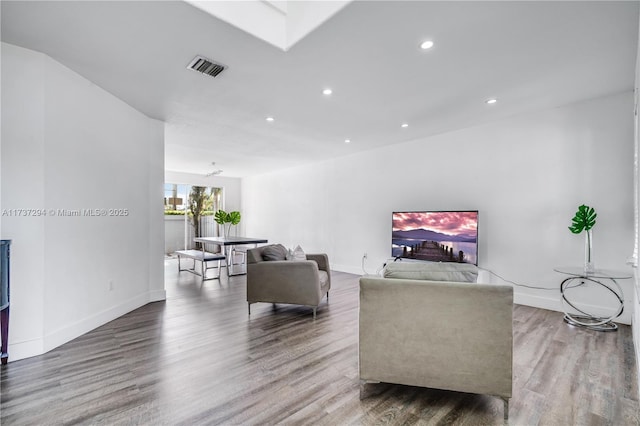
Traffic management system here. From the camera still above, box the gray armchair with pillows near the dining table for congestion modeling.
[247,245,331,319]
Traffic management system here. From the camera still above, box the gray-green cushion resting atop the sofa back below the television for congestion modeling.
[383,262,478,283]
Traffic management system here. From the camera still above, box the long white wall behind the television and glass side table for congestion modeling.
[242,93,633,323]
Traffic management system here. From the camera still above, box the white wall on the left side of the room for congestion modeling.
[1,44,165,360]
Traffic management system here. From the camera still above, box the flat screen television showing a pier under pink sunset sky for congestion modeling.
[391,210,478,266]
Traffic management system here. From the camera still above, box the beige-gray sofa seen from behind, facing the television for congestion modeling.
[359,265,513,419]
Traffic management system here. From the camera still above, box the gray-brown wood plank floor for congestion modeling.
[0,260,640,426]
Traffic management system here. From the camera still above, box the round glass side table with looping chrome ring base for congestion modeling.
[553,266,632,331]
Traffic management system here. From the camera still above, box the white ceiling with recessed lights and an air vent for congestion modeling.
[1,0,639,177]
